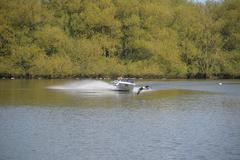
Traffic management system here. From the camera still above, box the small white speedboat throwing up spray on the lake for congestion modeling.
[112,78,136,91]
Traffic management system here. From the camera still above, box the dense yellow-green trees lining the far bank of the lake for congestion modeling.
[0,0,240,78]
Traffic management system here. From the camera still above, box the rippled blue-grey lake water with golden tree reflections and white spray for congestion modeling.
[0,80,240,160]
